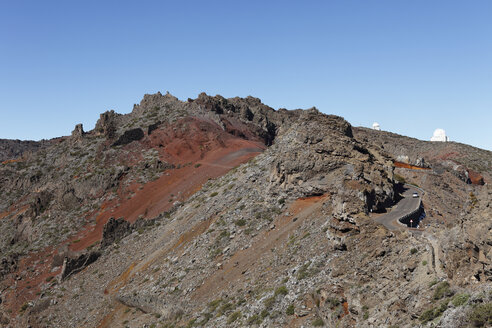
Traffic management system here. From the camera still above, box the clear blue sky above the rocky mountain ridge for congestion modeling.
[0,0,492,150]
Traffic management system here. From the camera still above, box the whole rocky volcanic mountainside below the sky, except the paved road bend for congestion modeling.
[0,93,492,328]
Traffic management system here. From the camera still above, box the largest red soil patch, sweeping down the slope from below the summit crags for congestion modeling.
[70,118,266,251]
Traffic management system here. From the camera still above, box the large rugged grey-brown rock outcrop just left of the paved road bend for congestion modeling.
[270,110,395,212]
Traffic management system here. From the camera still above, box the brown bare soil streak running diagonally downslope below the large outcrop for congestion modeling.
[192,196,328,301]
